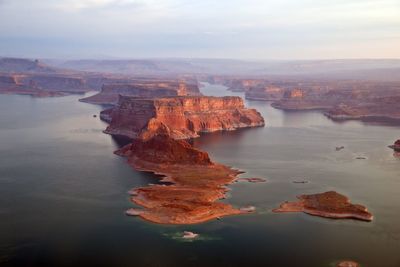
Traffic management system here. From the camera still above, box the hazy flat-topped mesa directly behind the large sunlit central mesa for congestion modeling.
[80,80,200,105]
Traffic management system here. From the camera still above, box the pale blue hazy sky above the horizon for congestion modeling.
[0,0,400,59]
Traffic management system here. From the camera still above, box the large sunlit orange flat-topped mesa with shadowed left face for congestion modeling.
[105,96,264,139]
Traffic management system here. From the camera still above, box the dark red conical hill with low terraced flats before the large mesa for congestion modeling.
[116,134,244,224]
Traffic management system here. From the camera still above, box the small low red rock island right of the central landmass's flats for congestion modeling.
[273,191,373,221]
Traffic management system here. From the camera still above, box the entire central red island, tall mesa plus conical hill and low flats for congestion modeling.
[107,96,264,224]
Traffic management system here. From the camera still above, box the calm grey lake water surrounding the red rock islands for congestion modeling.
[0,84,400,267]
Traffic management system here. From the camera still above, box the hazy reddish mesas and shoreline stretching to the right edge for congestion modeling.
[207,75,400,124]
